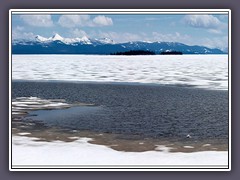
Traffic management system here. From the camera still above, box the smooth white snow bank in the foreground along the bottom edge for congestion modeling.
[12,136,228,168]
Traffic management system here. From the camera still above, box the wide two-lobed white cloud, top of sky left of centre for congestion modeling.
[58,15,113,28]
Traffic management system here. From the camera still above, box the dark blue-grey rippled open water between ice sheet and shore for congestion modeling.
[12,82,228,141]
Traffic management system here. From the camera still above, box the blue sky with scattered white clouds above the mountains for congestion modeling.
[12,14,228,50]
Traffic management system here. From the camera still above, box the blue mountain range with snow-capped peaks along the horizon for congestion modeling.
[12,34,226,54]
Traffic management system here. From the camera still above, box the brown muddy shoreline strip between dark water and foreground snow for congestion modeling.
[12,125,228,153]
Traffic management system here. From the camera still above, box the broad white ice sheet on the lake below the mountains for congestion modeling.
[12,55,228,90]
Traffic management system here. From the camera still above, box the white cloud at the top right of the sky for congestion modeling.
[184,15,222,29]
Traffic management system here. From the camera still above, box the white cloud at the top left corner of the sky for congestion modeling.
[20,15,53,27]
